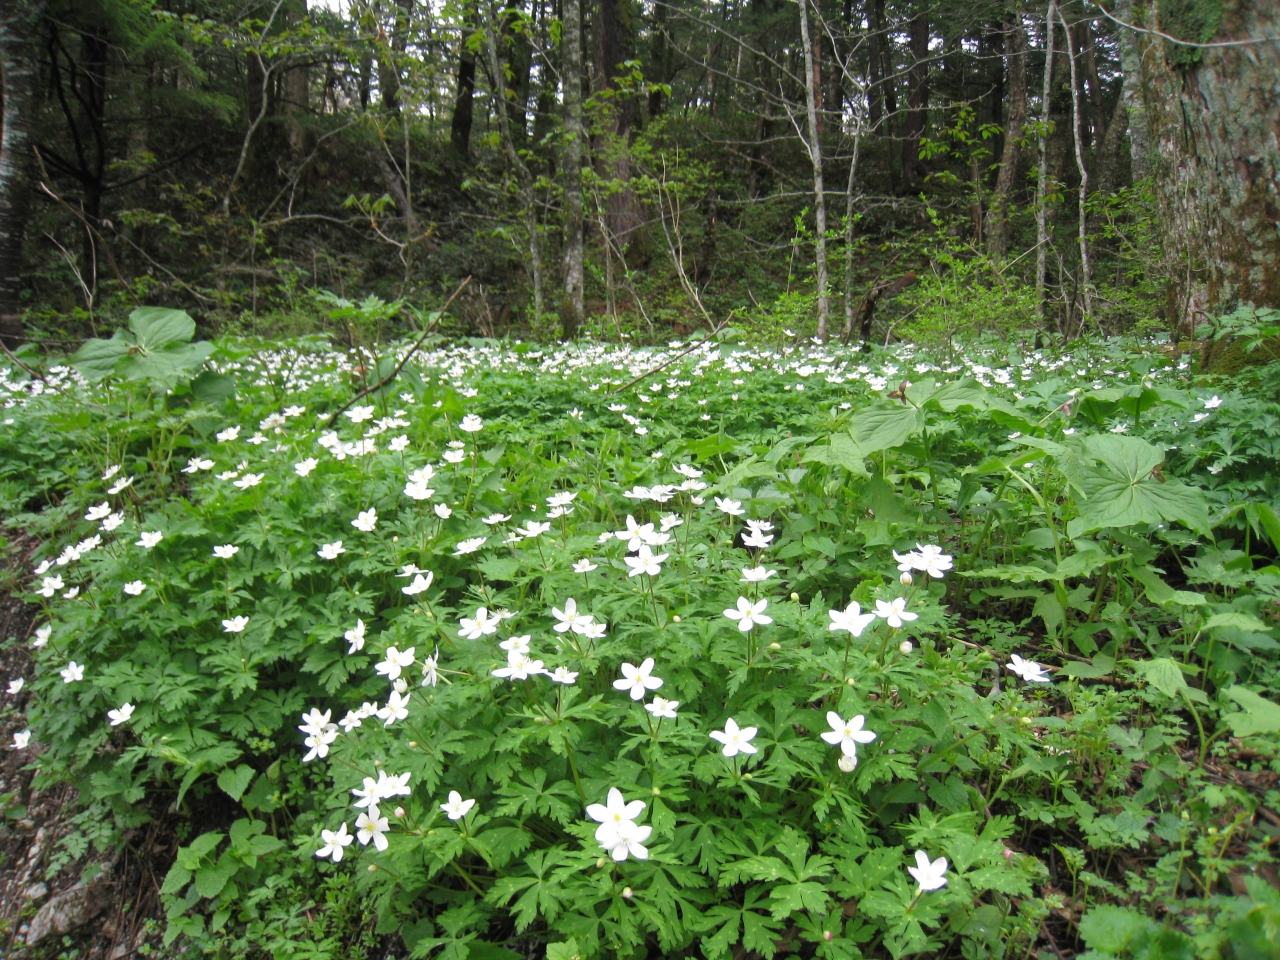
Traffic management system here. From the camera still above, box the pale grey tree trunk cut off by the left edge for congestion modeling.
[0,0,44,346]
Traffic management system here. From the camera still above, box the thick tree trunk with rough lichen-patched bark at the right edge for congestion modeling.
[1130,0,1280,332]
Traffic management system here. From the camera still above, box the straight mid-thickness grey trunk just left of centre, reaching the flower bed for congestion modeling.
[559,0,586,338]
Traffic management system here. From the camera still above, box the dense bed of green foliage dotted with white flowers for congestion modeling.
[0,320,1280,960]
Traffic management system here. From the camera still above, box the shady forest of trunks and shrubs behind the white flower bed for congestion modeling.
[0,0,1280,343]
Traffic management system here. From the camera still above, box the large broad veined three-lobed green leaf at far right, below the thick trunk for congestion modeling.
[1080,434,1208,536]
